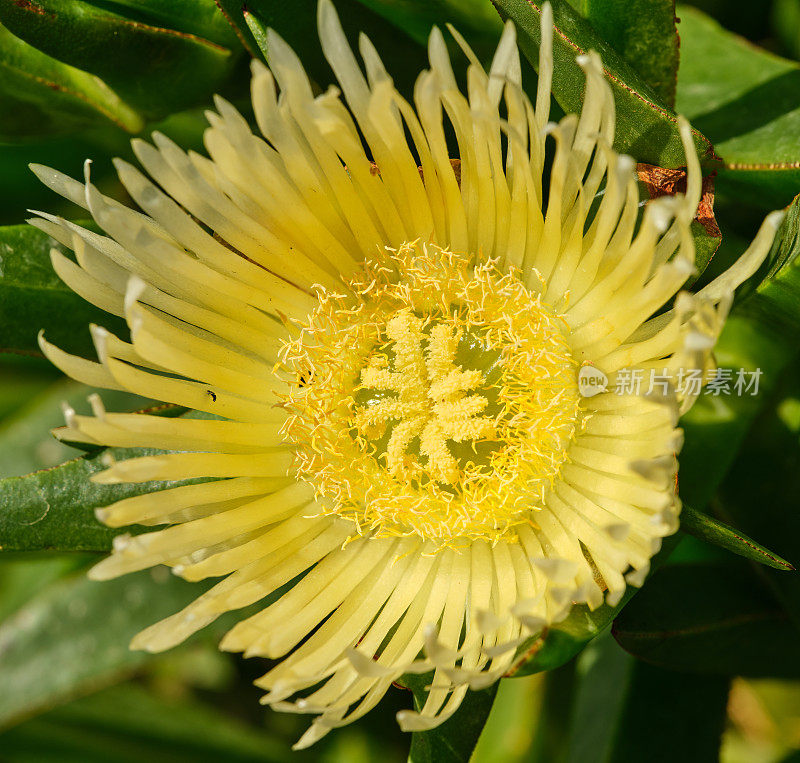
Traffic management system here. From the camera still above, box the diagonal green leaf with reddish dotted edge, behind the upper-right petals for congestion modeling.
[492,0,714,167]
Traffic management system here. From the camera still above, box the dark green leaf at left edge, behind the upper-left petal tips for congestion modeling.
[0,225,127,356]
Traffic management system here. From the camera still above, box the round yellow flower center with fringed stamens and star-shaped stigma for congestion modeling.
[282,242,583,545]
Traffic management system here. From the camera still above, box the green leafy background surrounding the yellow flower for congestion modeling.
[0,0,800,763]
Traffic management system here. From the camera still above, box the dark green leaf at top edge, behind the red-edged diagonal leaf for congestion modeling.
[570,0,680,106]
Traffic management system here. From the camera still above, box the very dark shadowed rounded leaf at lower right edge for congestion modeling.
[612,563,800,678]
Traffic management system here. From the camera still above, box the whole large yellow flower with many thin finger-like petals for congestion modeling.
[32,0,780,747]
